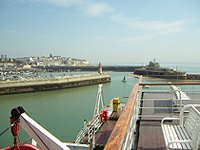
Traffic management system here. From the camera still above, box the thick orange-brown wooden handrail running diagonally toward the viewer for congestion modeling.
[104,84,139,150]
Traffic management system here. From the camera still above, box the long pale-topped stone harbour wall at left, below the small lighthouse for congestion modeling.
[0,73,111,95]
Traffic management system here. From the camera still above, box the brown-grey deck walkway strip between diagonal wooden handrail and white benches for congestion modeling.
[138,93,172,150]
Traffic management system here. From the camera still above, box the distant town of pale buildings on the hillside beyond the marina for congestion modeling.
[0,54,91,70]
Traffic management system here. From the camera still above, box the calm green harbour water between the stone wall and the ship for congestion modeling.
[0,72,137,148]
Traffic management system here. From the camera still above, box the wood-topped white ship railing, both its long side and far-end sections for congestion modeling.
[104,82,200,150]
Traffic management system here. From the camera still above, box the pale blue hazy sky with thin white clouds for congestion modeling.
[0,0,200,64]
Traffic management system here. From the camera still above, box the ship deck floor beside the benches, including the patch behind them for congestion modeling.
[137,89,200,150]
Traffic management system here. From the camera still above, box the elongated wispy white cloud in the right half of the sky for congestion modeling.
[111,15,186,34]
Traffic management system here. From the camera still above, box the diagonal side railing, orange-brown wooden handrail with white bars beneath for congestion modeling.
[104,84,140,150]
